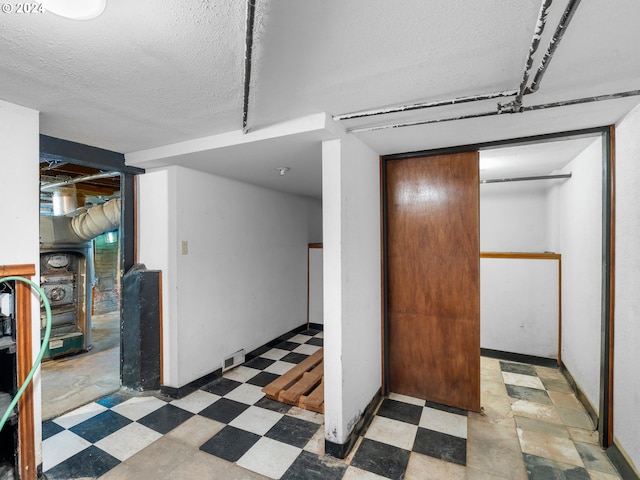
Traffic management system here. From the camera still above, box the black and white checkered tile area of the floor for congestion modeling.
[43,330,467,480]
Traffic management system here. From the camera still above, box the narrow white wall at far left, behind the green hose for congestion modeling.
[0,100,42,465]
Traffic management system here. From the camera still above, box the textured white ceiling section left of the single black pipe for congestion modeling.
[0,0,244,153]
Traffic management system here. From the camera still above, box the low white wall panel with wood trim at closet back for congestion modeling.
[480,258,559,358]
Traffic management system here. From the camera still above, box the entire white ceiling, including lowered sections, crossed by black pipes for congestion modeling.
[0,0,640,196]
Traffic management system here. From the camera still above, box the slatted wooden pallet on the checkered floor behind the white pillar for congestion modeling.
[262,348,324,413]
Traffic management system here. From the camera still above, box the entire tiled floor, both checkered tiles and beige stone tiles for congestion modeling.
[43,331,620,480]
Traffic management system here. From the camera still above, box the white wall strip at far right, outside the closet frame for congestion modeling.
[613,101,640,472]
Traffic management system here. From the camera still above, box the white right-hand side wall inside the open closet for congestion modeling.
[549,139,602,412]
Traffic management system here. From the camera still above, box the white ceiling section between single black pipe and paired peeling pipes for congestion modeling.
[251,0,540,129]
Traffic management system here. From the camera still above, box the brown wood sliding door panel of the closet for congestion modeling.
[386,152,480,411]
